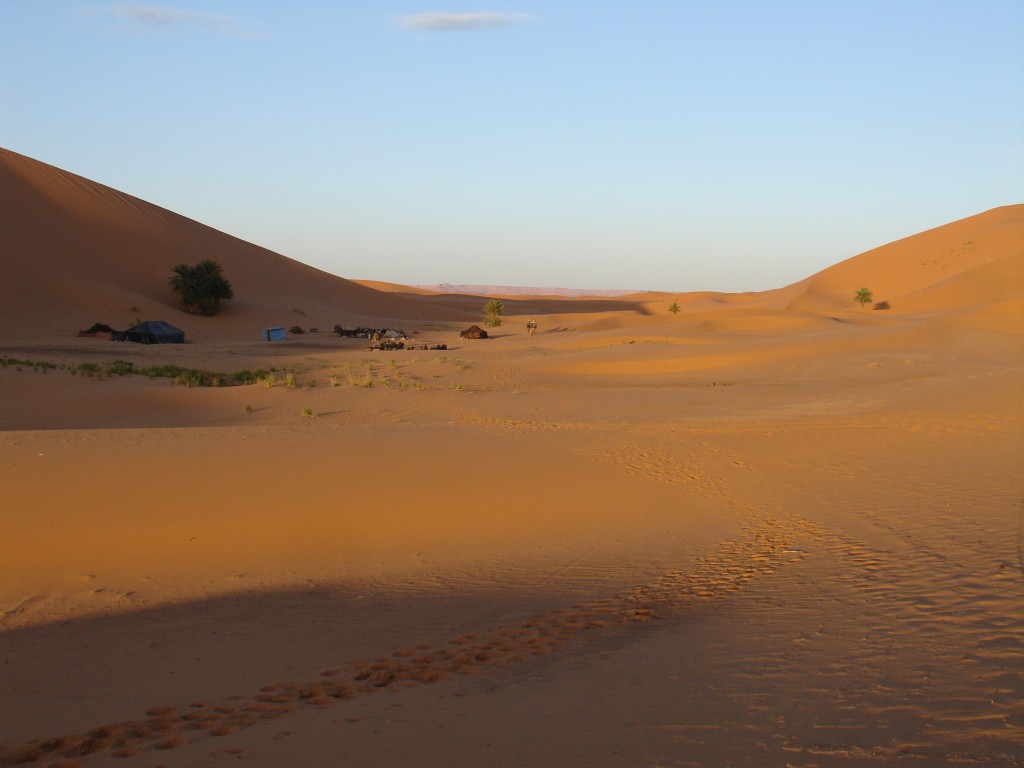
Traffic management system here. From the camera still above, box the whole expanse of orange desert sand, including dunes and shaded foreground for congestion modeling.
[0,151,1024,768]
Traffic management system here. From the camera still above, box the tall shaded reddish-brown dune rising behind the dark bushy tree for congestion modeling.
[0,151,473,338]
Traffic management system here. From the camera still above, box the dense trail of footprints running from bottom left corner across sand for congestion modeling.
[3,519,817,764]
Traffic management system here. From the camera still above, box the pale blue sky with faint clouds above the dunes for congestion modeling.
[0,0,1024,292]
